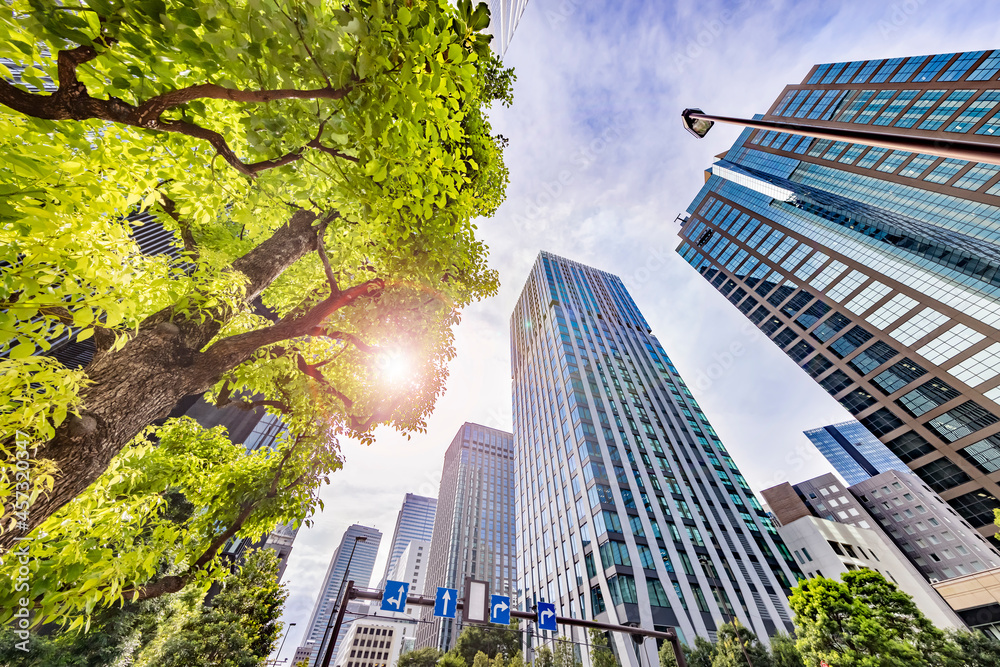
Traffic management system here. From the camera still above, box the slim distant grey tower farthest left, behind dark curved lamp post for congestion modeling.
[296,524,382,667]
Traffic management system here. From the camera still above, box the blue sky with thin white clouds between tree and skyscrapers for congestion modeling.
[274,0,1000,657]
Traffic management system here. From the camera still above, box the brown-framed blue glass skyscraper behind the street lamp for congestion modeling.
[678,51,1000,534]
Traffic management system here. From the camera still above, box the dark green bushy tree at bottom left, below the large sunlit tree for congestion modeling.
[137,549,287,667]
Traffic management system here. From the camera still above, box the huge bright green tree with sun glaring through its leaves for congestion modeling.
[0,0,512,628]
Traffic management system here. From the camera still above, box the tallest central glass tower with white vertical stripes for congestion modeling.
[511,252,801,666]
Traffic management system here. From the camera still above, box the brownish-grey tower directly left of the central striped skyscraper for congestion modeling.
[416,422,515,651]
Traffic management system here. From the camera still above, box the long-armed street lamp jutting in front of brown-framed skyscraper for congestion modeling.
[681,109,1000,165]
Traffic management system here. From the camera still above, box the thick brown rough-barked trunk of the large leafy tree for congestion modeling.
[0,211,317,553]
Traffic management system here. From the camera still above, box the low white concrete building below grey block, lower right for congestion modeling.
[778,516,965,629]
